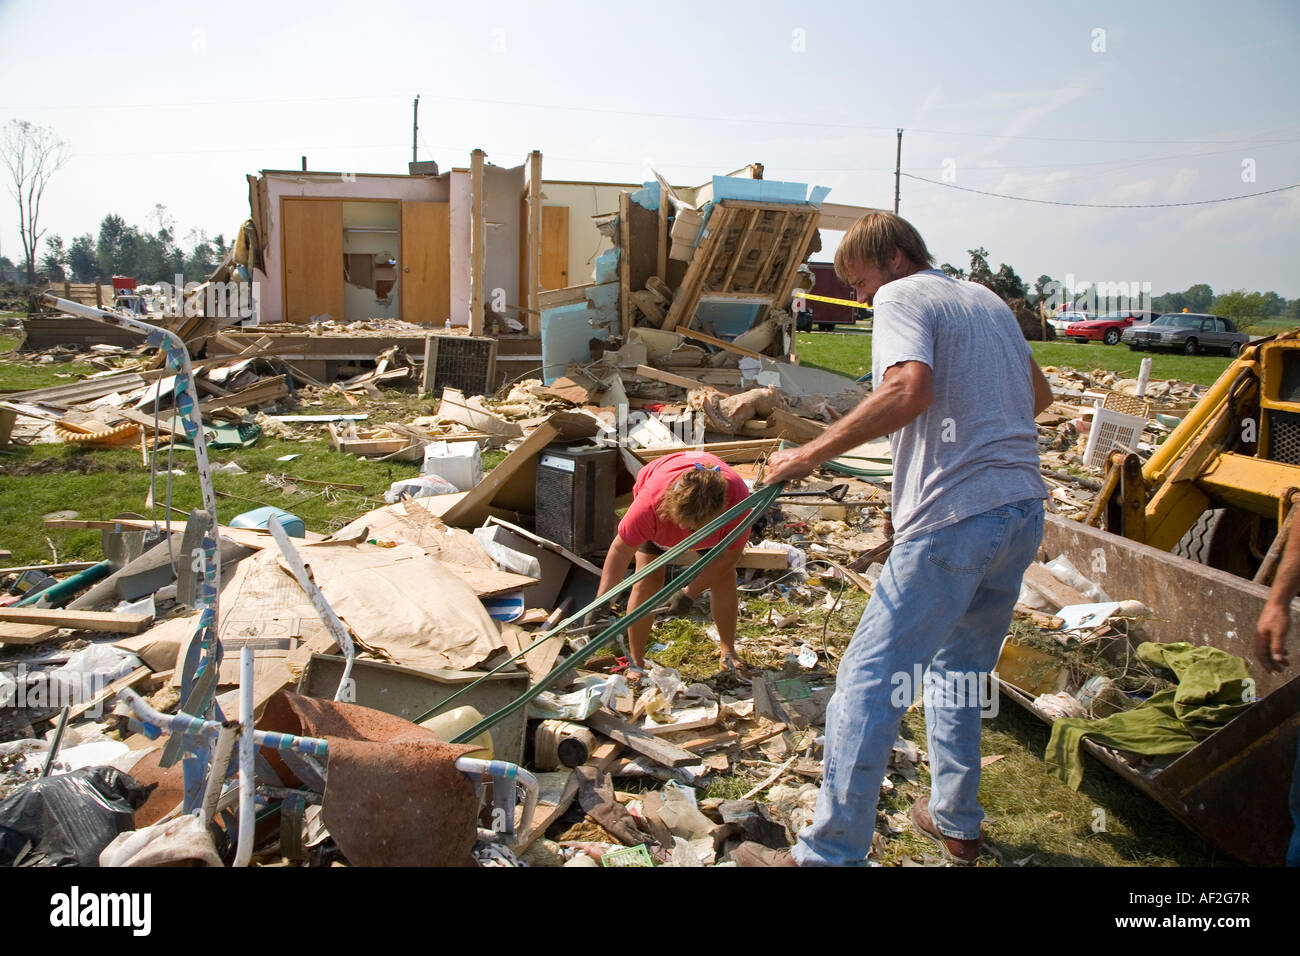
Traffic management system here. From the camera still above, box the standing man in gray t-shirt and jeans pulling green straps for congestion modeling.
[736,212,1052,866]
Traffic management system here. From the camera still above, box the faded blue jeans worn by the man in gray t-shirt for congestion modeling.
[793,498,1043,866]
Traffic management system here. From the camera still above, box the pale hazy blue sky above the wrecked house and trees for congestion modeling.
[0,0,1300,298]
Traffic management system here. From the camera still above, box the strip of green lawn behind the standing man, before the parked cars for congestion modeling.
[796,332,1230,385]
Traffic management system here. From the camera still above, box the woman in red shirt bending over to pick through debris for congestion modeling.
[598,451,749,671]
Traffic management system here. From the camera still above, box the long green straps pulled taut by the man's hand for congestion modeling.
[434,483,783,744]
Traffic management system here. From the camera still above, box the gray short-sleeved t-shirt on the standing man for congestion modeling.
[871,269,1047,541]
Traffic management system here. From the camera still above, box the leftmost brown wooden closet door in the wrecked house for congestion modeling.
[280,199,343,323]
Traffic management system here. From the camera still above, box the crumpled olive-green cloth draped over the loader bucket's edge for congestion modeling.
[1044,641,1255,790]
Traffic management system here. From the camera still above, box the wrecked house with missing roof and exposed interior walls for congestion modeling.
[233,156,865,384]
